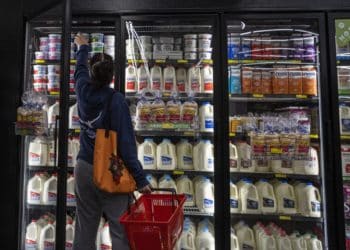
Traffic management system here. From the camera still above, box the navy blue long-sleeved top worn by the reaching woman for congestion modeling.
[74,45,149,188]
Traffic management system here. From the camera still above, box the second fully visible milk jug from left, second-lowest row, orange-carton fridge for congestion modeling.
[255,179,277,214]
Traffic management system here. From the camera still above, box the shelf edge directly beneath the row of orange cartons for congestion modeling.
[230,94,319,103]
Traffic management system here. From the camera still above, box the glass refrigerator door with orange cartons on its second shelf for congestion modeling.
[225,15,327,249]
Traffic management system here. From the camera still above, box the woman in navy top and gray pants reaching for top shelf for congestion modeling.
[73,33,151,250]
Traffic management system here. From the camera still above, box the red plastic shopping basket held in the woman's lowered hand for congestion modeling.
[119,189,186,250]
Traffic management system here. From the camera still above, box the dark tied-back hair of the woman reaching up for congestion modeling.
[90,53,114,88]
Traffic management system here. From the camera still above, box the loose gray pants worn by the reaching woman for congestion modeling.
[73,160,129,250]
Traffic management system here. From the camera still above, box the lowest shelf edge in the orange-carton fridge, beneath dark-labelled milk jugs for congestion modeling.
[231,213,323,223]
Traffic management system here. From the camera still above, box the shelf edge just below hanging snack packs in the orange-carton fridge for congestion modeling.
[230,172,321,182]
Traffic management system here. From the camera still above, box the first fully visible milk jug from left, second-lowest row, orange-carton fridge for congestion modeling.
[237,179,260,214]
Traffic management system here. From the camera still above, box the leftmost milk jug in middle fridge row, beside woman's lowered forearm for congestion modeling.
[137,138,157,169]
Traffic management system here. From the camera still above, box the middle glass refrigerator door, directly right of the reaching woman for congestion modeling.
[121,15,220,249]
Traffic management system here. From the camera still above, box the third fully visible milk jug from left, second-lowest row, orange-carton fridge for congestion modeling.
[275,180,297,214]
